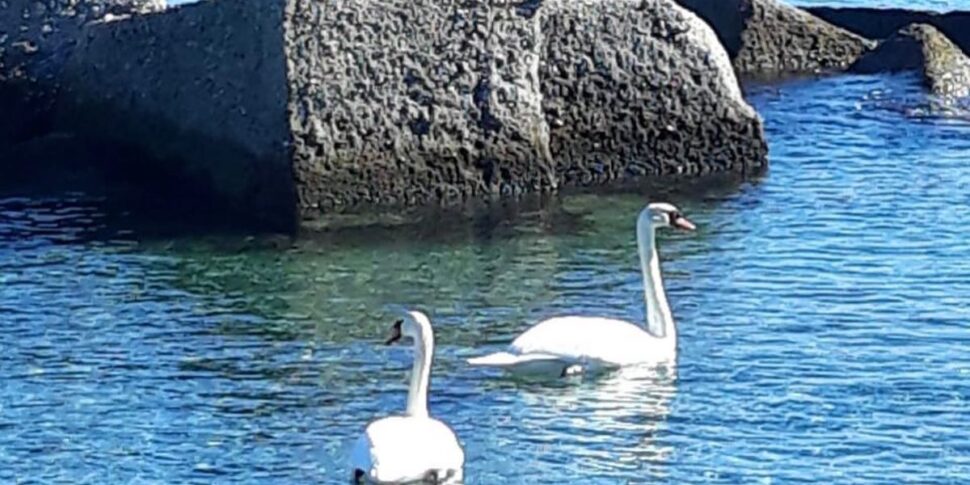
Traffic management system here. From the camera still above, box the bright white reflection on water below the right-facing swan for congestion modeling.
[515,365,677,480]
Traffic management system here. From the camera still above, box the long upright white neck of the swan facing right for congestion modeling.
[637,218,677,345]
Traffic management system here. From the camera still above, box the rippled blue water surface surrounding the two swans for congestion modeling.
[0,72,970,484]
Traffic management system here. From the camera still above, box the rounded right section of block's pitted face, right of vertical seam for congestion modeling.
[541,0,767,185]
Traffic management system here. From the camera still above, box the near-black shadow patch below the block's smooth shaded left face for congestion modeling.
[0,132,288,242]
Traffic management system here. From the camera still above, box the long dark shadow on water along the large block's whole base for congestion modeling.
[0,125,758,251]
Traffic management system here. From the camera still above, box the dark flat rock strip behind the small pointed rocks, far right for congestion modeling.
[807,7,970,54]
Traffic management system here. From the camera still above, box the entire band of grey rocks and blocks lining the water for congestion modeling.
[0,0,970,231]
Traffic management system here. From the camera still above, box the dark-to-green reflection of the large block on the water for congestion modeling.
[0,157,757,354]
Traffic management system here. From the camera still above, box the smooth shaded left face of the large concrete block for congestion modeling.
[57,0,295,229]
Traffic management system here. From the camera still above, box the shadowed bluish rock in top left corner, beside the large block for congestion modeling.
[0,0,165,144]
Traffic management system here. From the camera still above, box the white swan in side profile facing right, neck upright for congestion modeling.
[468,202,695,376]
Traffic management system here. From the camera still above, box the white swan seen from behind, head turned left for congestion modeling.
[351,311,465,483]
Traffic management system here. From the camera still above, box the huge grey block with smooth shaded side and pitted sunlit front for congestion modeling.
[57,0,767,228]
